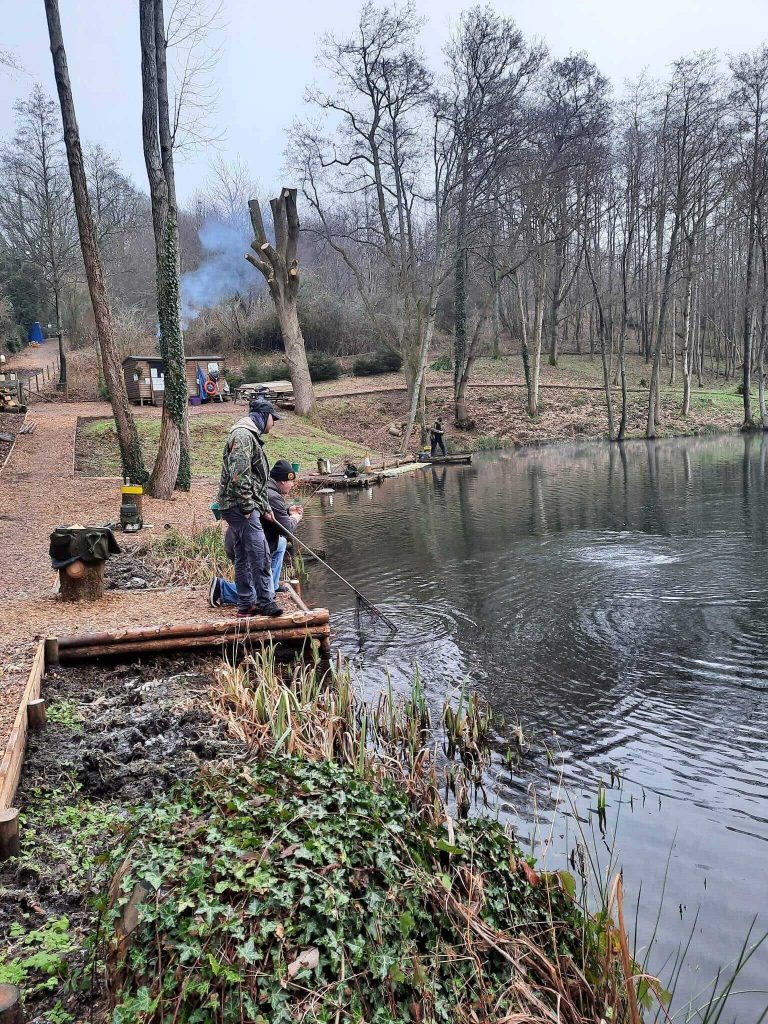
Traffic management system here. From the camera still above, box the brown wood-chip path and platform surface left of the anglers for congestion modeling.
[0,402,243,751]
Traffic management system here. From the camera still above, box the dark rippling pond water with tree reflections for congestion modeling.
[304,436,768,1022]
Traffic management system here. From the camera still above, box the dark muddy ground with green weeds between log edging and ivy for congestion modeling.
[0,658,239,1024]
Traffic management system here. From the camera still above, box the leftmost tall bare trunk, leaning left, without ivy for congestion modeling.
[45,0,146,483]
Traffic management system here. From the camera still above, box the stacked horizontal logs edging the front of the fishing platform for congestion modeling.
[58,608,330,647]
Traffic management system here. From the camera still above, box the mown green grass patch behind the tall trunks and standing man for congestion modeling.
[76,413,369,476]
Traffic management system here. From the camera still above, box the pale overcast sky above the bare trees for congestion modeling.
[0,0,768,200]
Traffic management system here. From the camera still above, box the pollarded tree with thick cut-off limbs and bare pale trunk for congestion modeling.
[246,188,315,416]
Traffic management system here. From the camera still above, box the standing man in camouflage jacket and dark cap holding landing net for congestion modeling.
[218,398,282,615]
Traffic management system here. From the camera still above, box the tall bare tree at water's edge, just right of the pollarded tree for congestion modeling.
[293,2,455,449]
